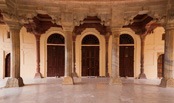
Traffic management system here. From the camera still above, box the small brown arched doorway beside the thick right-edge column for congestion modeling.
[158,54,164,78]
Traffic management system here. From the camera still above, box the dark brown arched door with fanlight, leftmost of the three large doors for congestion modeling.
[47,33,65,77]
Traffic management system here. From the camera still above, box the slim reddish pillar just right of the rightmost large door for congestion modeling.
[138,34,146,79]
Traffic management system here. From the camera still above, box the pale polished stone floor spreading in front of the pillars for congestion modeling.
[0,78,174,103]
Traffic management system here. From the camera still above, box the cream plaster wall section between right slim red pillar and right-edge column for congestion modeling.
[144,27,164,78]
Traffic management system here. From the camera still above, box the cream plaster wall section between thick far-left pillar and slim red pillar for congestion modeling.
[20,27,36,79]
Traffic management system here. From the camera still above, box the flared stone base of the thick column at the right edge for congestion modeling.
[159,78,174,88]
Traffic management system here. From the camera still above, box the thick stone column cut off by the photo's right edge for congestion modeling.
[160,0,174,88]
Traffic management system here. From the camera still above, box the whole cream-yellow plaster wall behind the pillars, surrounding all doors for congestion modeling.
[0,26,164,79]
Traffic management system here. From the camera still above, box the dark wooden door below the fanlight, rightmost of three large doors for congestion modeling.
[119,46,134,77]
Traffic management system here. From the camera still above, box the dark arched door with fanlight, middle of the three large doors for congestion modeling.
[82,34,99,76]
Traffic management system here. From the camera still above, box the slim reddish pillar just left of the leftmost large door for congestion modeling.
[34,35,42,78]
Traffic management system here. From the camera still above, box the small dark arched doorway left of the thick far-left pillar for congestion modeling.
[5,53,11,77]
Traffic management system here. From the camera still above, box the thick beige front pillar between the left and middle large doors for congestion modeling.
[63,31,74,85]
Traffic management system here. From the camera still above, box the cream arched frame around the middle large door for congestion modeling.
[75,28,106,77]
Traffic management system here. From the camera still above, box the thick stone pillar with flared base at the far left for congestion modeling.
[5,25,24,88]
